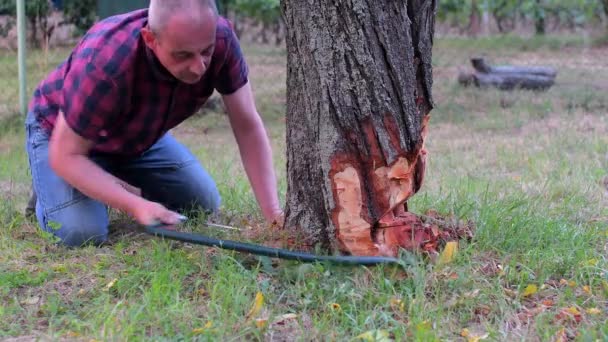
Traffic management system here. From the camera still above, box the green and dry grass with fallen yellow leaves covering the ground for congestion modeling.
[0,37,608,341]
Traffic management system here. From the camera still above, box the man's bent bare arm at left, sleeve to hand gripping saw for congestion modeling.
[49,112,178,224]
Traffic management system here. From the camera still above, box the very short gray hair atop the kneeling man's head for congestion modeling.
[148,0,218,34]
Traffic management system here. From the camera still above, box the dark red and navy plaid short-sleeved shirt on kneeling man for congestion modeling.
[29,9,248,156]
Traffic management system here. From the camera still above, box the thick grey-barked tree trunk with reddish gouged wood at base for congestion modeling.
[281,0,436,255]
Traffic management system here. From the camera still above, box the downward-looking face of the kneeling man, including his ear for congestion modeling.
[142,9,217,84]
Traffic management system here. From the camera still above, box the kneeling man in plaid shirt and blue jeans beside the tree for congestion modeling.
[26,0,282,246]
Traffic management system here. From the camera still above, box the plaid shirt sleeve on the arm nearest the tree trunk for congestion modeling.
[215,28,249,95]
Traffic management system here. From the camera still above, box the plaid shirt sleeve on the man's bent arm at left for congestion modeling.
[63,62,121,143]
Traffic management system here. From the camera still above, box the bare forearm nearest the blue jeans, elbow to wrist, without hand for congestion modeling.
[51,155,141,213]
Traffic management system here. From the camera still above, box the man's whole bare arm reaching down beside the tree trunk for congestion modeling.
[223,82,283,223]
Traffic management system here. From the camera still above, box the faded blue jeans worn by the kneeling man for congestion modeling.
[25,113,220,246]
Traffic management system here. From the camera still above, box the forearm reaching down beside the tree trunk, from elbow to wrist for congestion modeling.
[237,125,281,220]
